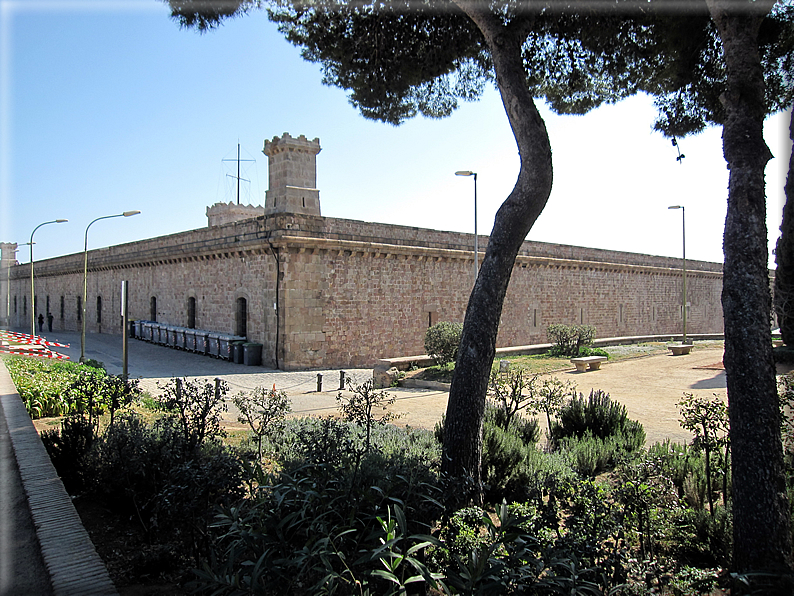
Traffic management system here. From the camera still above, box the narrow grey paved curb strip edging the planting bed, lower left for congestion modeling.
[0,365,118,596]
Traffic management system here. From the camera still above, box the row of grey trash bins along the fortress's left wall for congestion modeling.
[130,321,262,366]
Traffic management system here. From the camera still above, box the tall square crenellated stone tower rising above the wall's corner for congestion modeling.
[262,132,320,215]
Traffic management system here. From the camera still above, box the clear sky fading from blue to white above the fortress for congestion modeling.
[0,0,791,262]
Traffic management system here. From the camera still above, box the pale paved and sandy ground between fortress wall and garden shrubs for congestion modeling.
[23,332,744,445]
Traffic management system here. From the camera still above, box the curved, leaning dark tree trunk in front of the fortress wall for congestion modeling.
[441,0,552,491]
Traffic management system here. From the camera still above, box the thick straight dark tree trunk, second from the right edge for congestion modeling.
[707,0,791,573]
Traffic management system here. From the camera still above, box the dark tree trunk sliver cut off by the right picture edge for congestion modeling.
[775,110,794,346]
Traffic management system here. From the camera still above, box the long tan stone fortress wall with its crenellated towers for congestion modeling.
[0,133,723,370]
